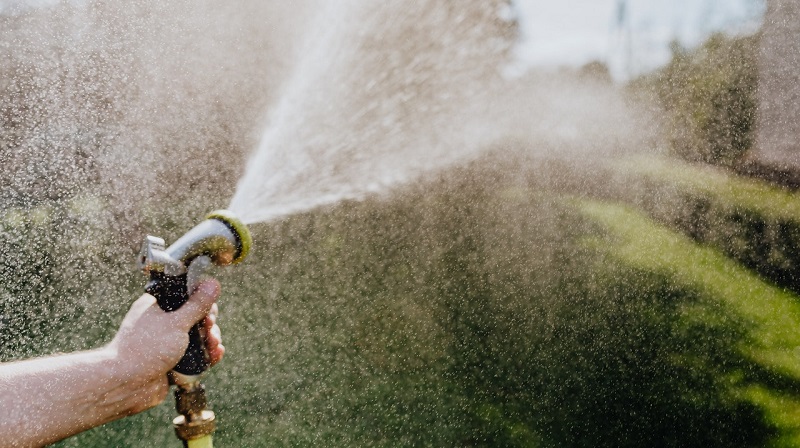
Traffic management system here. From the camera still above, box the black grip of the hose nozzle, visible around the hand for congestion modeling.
[144,271,210,375]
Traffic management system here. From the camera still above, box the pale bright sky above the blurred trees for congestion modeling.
[512,0,765,80]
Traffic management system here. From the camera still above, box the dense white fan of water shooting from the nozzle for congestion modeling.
[230,1,514,222]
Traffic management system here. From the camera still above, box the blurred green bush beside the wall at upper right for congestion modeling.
[632,34,758,166]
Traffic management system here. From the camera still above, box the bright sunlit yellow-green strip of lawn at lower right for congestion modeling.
[578,201,800,446]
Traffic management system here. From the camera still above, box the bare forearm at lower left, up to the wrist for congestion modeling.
[0,346,167,447]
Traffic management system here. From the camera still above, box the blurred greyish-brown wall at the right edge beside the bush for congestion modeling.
[756,0,800,170]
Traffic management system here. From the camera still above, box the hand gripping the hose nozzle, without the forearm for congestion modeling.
[107,280,225,413]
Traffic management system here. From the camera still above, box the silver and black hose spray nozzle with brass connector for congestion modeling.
[139,210,252,448]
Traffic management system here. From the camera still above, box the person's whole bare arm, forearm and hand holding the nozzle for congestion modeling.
[0,280,225,446]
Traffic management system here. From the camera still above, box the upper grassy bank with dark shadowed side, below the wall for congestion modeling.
[607,156,800,293]
